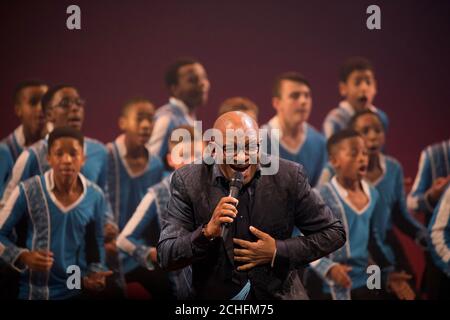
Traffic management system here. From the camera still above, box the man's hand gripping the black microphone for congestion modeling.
[205,197,239,238]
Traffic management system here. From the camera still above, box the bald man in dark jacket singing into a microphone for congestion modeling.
[157,111,345,300]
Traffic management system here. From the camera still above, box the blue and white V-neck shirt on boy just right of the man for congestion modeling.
[311,177,393,300]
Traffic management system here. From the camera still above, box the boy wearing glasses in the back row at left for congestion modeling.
[2,85,107,203]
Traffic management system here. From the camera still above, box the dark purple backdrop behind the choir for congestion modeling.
[0,0,450,176]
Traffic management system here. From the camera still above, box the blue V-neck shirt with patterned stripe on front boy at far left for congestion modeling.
[0,170,106,300]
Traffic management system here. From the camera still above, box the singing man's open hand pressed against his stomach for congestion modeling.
[233,227,276,271]
